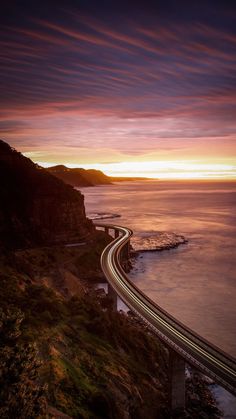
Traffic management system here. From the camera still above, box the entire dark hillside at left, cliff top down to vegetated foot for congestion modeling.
[0,141,219,419]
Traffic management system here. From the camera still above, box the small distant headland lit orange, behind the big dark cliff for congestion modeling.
[47,165,111,186]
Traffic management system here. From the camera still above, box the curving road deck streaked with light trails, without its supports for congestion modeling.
[96,224,236,396]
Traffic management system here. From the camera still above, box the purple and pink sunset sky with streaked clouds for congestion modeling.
[0,0,236,179]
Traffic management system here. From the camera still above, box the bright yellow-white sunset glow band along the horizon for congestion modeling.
[33,159,236,180]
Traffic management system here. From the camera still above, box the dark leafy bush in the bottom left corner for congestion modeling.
[0,308,47,419]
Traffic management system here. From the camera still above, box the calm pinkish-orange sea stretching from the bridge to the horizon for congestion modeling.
[82,181,236,356]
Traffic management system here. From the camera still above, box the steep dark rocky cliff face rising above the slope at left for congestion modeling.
[0,141,94,247]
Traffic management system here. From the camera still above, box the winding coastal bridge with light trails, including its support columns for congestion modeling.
[96,224,236,409]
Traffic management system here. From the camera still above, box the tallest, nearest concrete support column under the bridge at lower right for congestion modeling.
[169,349,185,410]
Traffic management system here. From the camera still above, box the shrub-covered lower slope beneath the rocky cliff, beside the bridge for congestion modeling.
[0,240,221,419]
